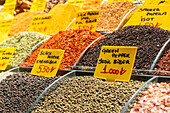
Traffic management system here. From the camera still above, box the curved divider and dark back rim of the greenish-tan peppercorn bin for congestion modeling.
[27,70,152,113]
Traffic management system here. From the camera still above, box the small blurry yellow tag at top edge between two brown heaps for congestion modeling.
[30,0,46,12]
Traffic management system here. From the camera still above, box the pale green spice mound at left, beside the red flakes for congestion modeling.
[0,32,49,66]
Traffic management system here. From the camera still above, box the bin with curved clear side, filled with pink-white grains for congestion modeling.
[121,76,170,113]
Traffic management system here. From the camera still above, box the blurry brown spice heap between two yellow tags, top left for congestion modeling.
[14,0,33,15]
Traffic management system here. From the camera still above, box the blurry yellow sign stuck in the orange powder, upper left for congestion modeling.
[28,15,51,34]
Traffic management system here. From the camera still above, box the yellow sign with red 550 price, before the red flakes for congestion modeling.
[31,49,64,77]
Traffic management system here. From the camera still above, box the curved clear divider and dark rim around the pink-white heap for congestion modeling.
[121,76,170,113]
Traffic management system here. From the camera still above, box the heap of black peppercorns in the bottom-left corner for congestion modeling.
[0,72,58,113]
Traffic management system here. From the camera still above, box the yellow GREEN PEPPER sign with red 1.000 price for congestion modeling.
[94,46,137,82]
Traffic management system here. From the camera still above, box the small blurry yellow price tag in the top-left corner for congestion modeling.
[2,0,16,15]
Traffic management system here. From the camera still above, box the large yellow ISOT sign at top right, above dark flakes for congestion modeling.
[125,6,170,30]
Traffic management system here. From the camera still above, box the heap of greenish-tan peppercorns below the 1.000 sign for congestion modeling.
[32,76,144,113]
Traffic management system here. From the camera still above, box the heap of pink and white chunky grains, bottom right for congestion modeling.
[131,83,170,113]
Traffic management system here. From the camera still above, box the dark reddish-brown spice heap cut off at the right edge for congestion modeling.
[154,49,170,76]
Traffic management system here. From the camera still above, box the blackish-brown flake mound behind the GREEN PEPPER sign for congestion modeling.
[78,25,170,69]
